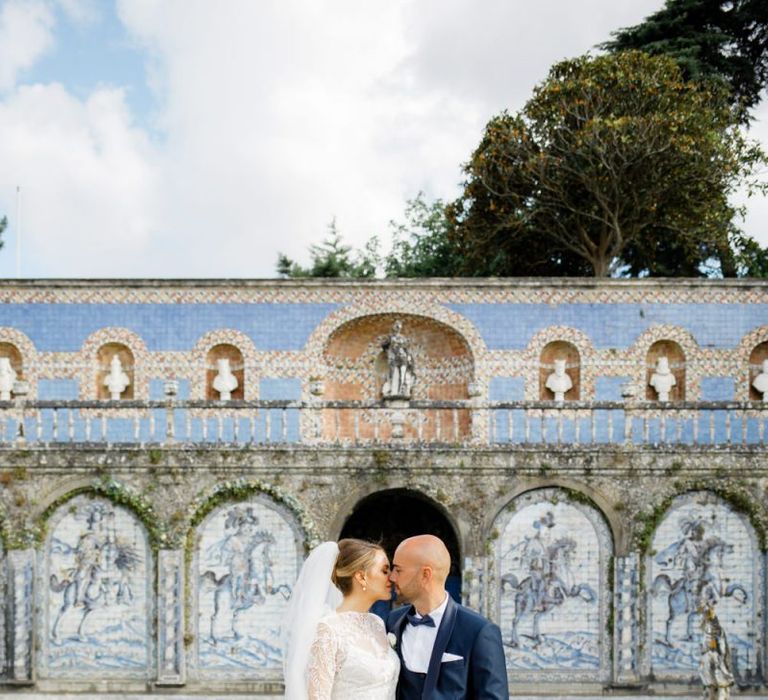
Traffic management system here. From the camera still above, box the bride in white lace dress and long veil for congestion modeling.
[283,539,400,700]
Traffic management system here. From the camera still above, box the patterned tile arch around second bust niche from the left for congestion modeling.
[80,328,149,401]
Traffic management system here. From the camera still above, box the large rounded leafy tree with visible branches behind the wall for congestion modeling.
[449,51,765,276]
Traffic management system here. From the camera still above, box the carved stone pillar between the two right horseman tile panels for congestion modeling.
[613,554,640,685]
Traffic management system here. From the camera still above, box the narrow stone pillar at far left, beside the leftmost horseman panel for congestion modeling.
[6,549,35,685]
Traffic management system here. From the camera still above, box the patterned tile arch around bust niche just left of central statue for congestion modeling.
[190,328,261,401]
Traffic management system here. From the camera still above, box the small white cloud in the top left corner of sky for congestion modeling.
[0,0,54,91]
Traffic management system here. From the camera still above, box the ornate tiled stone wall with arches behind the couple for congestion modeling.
[0,281,768,697]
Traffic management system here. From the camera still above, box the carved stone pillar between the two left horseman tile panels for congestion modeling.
[157,549,186,685]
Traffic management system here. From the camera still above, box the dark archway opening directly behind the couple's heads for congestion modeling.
[339,489,461,615]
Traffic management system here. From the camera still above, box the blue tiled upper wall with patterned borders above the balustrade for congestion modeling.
[0,281,768,401]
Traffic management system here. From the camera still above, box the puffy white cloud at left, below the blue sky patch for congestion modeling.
[0,84,156,276]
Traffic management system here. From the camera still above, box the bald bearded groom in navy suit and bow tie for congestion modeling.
[387,535,509,700]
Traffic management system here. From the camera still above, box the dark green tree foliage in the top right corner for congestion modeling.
[603,0,768,115]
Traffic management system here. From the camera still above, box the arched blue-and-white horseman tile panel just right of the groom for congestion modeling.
[489,487,613,681]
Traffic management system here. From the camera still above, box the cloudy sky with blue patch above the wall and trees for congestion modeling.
[0,0,768,277]
